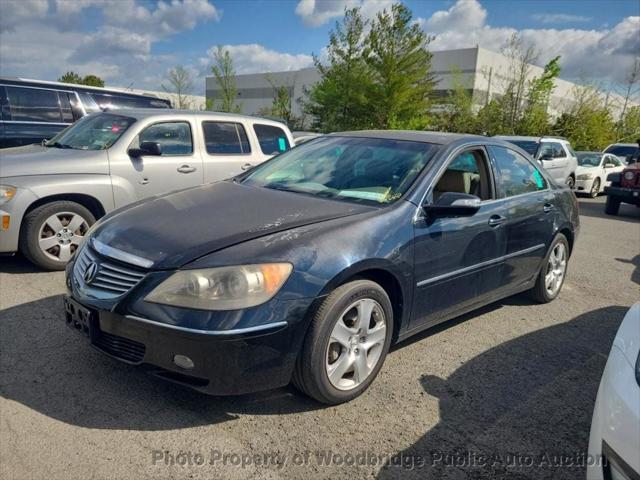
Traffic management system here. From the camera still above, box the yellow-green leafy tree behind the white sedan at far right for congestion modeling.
[553,85,615,150]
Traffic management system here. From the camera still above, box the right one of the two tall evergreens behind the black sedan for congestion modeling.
[365,3,435,128]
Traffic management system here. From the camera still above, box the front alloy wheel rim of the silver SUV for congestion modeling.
[38,212,89,263]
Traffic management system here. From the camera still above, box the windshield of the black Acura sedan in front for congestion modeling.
[241,137,436,204]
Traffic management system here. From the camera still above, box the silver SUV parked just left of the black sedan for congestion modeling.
[0,109,293,270]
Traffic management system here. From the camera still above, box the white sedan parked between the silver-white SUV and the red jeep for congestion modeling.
[576,152,625,198]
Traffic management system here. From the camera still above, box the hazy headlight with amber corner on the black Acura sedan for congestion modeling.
[145,263,293,310]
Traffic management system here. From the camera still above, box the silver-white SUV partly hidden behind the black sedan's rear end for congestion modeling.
[496,135,578,189]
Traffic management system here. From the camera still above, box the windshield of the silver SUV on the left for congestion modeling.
[46,113,136,150]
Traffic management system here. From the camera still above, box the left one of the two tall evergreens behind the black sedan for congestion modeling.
[303,8,372,132]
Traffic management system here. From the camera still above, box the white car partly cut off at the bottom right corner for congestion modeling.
[587,302,640,480]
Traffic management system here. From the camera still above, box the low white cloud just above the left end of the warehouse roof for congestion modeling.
[200,43,313,73]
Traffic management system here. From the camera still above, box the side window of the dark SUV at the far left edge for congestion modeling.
[6,86,62,123]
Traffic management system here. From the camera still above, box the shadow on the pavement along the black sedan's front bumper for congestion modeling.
[0,296,322,430]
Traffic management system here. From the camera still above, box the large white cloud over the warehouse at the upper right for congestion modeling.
[418,0,640,82]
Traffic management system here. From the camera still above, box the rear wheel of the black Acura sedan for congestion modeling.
[531,233,569,303]
